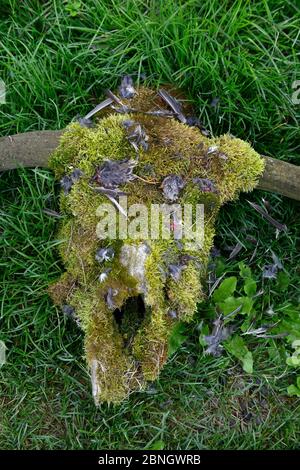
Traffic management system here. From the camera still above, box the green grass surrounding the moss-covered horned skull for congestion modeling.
[0,0,300,449]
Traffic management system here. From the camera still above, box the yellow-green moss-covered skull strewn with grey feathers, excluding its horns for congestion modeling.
[49,83,264,403]
